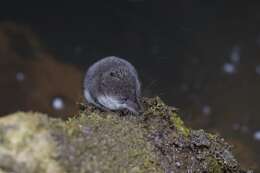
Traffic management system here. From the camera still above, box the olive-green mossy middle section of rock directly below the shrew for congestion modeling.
[53,113,162,172]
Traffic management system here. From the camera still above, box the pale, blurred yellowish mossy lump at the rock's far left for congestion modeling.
[0,112,64,173]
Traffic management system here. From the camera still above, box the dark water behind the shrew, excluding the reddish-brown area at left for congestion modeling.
[1,0,260,170]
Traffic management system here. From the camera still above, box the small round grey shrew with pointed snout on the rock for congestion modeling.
[84,56,142,114]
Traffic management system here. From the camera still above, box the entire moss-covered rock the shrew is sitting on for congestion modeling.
[0,97,250,173]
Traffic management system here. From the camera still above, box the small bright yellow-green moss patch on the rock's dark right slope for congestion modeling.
[170,112,190,137]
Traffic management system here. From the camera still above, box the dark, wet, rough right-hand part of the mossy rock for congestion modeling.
[140,98,248,172]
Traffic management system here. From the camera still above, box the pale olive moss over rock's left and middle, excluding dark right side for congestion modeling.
[0,113,163,173]
